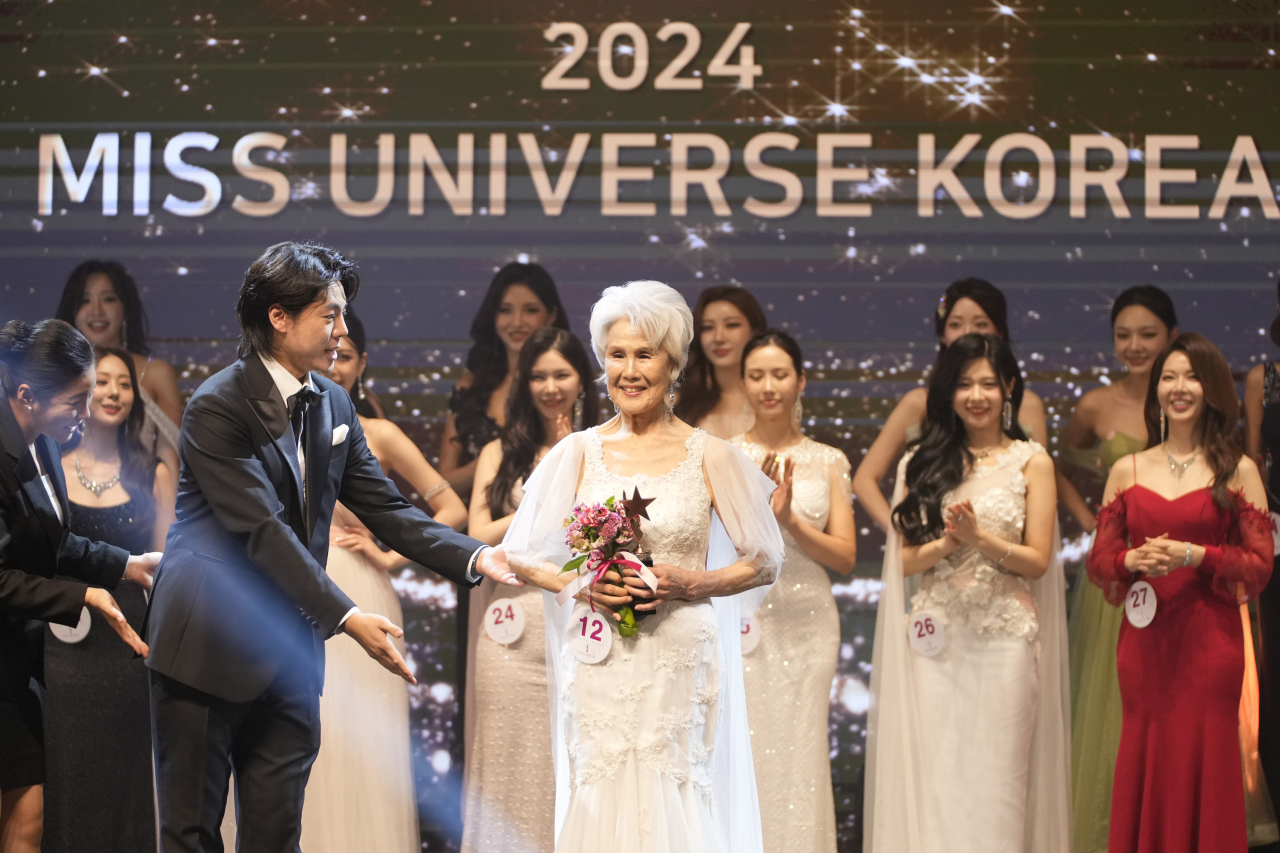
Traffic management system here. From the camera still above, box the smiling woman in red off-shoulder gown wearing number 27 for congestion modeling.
[1088,333,1272,853]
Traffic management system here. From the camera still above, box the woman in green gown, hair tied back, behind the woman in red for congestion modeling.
[1057,284,1178,853]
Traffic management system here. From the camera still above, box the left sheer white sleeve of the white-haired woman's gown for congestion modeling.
[502,433,586,569]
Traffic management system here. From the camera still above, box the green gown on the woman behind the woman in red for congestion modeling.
[1065,433,1147,853]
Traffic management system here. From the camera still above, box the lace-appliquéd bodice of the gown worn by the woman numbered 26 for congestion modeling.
[911,442,1044,642]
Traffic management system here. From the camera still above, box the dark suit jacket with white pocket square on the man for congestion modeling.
[145,355,481,702]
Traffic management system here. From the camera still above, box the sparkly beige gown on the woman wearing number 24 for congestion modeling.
[462,483,556,853]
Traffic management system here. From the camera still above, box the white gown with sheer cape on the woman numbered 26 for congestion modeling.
[867,442,1070,853]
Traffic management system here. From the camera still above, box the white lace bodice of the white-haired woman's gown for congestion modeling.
[577,429,712,571]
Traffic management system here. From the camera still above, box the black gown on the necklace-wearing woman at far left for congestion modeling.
[42,498,156,853]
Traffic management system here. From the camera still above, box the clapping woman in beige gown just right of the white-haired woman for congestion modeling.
[731,329,858,853]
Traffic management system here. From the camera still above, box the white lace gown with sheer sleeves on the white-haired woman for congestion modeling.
[506,429,782,853]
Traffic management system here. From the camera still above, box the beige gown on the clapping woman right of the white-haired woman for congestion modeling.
[732,435,852,853]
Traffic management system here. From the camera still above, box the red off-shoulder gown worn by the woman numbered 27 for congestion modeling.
[1088,484,1274,853]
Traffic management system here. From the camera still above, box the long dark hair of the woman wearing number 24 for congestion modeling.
[488,325,599,515]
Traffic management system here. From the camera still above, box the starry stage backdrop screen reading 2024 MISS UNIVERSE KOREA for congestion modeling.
[0,0,1280,850]
